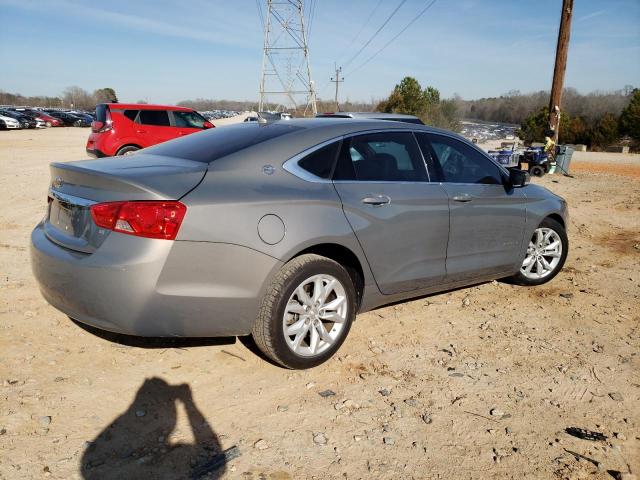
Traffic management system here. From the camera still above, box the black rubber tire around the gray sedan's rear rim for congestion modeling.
[251,254,357,369]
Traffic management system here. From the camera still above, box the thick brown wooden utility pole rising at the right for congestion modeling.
[549,0,573,143]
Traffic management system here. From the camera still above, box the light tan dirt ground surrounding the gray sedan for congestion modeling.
[0,128,640,480]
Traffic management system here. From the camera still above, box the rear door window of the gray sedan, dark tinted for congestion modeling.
[333,132,428,182]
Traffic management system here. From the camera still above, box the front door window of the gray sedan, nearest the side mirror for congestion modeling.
[428,134,502,185]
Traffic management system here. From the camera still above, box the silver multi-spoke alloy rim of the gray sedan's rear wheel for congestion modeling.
[282,274,349,357]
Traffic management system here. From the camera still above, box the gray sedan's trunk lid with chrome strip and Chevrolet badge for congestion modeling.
[44,153,207,253]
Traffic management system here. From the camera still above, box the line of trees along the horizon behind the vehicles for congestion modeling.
[0,82,640,150]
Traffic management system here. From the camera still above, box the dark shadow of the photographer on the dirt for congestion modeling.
[81,378,225,480]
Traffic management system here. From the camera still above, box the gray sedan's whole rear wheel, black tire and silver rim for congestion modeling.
[252,254,356,369]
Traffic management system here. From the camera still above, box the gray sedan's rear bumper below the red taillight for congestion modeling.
[31,224,281,337]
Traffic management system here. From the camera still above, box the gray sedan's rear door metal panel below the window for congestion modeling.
[335,181,449,294]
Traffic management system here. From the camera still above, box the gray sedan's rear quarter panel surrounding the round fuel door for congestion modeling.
[178,150,374,292]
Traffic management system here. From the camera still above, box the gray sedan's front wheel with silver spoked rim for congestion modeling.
[513,218,569,285]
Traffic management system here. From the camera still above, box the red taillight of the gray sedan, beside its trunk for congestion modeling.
[90,201,187,240]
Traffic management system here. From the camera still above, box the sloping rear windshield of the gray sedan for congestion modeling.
[145,122,302,163]
